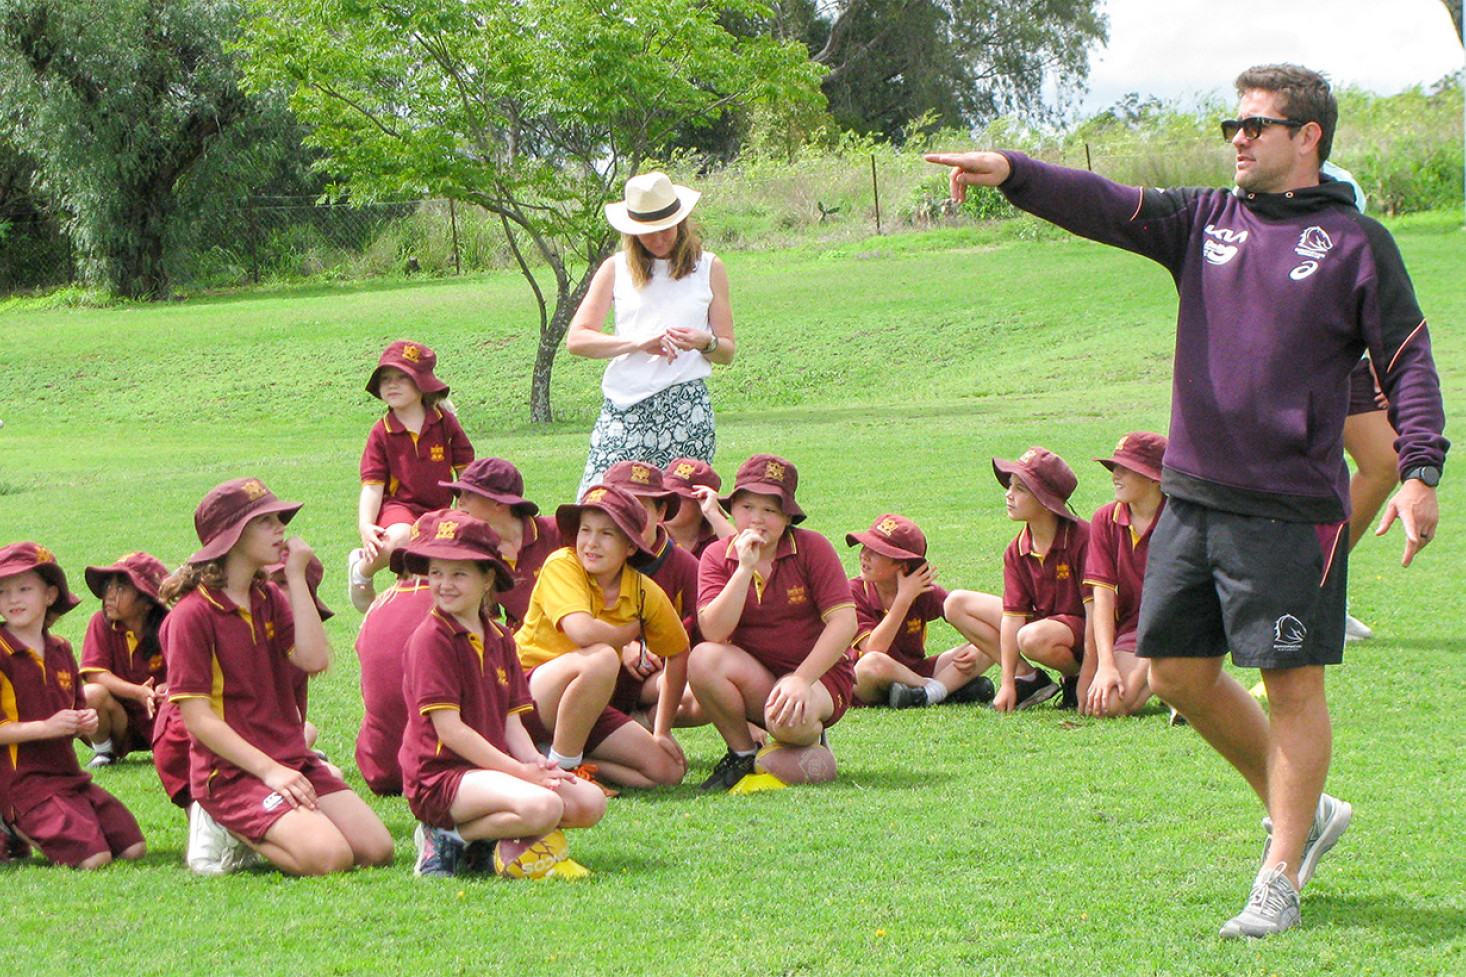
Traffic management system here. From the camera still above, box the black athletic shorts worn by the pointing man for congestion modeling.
[1136,499,1349,669]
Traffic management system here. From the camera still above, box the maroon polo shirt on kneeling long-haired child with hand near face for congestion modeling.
[163,581,311,797]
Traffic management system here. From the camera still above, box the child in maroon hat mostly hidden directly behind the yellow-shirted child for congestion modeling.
[605,461,707,726]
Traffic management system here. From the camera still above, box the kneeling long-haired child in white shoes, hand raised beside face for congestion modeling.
[161,478,393,876]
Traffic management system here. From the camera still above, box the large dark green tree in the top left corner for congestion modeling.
[0,0,251,298]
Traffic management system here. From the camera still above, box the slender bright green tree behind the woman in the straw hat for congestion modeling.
[242,0,819,421]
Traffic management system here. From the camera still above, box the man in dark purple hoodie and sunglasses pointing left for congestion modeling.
[927,65,1448,937]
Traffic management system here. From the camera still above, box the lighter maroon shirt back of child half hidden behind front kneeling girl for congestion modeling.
[356,577,432,794]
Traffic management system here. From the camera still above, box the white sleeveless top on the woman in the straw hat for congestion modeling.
[601,251,715,409]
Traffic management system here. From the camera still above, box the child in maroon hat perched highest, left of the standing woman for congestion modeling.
[346,339,474,613]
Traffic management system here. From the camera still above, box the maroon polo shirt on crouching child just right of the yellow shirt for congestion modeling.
[698,527,853,676]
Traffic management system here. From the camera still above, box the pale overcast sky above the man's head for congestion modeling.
[1082,0,1463,113]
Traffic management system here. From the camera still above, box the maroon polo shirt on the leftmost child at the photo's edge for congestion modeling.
[0,625,91,820]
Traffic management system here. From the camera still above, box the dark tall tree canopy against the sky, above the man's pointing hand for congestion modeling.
[809,0,1108,139]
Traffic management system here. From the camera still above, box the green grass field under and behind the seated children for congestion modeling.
[0,214,1466,977]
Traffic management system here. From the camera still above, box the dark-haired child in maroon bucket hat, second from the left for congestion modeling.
[81,552,169,769]
